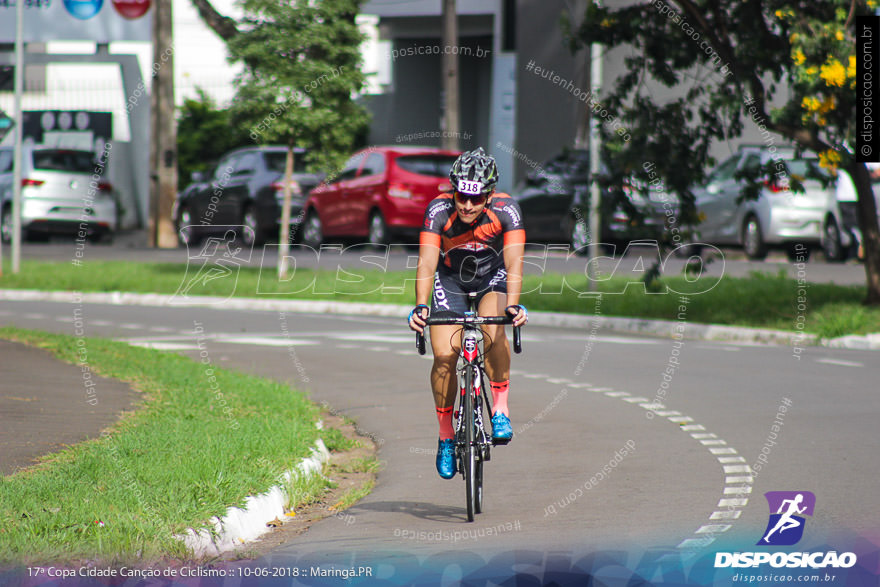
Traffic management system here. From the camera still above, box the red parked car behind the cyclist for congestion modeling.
[302,146,460,247]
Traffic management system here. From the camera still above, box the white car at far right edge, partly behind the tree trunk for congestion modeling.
[822,163,880,263]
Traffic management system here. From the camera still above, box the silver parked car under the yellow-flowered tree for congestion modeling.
[694,147,836,260]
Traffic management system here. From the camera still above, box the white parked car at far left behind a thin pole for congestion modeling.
[0,145,117,242]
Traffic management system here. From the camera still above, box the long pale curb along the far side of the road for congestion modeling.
[0,289,880,350]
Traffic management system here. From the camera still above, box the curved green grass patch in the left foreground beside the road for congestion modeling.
[0,328,323,566]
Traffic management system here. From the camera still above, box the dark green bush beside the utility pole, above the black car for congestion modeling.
[177,88,250,189]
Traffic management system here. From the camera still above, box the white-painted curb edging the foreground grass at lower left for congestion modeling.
[177,436,330,558]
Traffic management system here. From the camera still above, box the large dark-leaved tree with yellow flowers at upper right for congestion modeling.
[563,0,880,305]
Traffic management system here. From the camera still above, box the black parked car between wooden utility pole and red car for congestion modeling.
[173,145,321,249]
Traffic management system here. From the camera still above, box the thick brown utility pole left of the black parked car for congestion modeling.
[148,0,177,249]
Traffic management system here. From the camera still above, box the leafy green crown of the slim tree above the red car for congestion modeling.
[229,0,368,172]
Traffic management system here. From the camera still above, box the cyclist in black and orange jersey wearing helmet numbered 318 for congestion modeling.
[409,147,528,479]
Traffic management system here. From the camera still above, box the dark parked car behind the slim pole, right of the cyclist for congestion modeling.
[511,149,678,250]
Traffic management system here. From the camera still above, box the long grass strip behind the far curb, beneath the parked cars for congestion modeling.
[0,261,880,338]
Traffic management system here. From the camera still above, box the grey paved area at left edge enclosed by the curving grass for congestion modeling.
[0,340,139,475]
